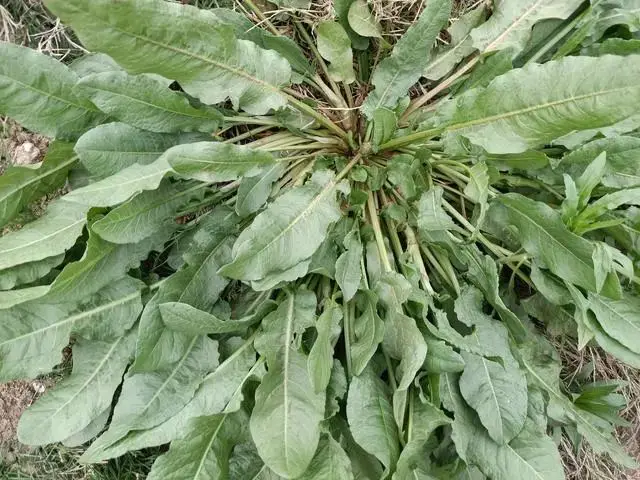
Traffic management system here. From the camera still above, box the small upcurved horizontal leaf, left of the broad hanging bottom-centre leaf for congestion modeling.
[158,302,273,335]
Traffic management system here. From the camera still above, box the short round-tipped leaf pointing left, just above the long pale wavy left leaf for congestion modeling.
[75,123,202,178]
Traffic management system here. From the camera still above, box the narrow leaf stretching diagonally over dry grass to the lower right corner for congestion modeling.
[520,337,637,468]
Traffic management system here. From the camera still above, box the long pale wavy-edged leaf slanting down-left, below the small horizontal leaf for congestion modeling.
[82,338,260,463]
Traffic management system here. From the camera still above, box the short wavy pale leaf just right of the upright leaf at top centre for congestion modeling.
[424,7,485,80]
